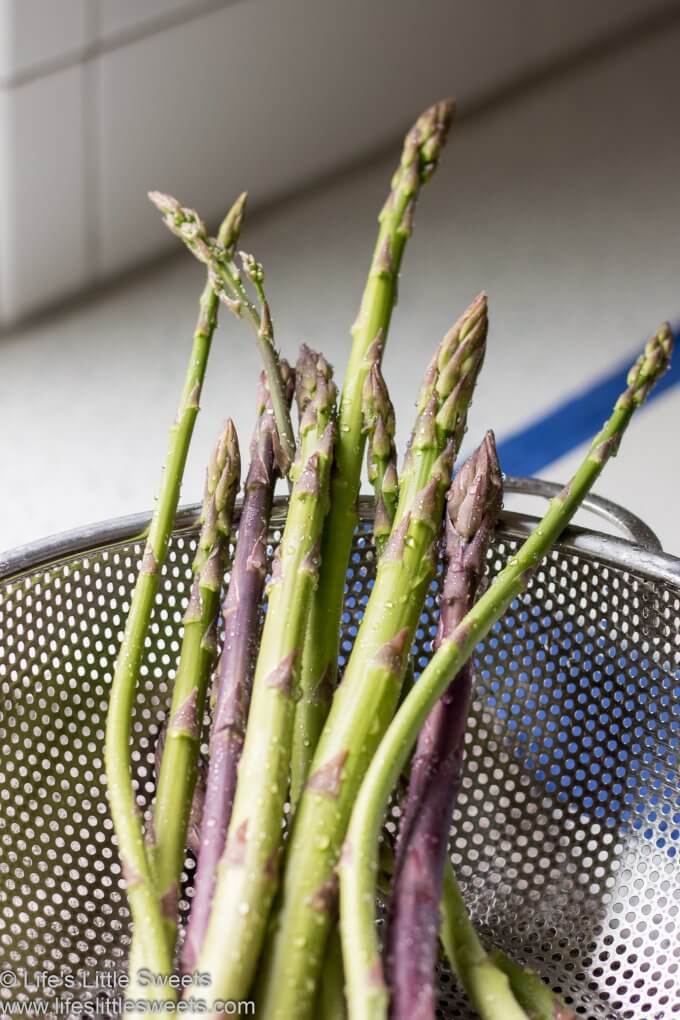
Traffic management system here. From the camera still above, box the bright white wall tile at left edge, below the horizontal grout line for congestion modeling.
[0,64,89,320]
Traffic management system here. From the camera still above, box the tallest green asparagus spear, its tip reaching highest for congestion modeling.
[294,101,454,787]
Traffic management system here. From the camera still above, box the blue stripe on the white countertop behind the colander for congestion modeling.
[498,326,680,475]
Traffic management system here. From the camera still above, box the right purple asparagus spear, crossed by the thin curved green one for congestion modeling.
[385,431,503,1020]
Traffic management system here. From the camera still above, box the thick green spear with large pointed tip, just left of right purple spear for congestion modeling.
[259,295,486,1020]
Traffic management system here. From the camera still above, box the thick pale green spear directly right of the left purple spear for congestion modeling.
[197,353,335,1000]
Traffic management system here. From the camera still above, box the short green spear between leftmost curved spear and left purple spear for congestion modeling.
[152,421,241,949]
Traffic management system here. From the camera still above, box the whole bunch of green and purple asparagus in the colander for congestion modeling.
[106,102,672,1020]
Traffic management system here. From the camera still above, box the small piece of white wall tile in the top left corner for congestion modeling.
[0,0,89,82]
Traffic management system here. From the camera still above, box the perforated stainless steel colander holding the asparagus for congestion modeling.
[0,479,680,1020]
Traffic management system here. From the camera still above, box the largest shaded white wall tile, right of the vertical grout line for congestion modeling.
[91,0,680,274]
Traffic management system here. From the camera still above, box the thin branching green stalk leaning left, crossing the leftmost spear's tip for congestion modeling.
[149,192,295,475]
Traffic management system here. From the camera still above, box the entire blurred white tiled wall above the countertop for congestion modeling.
[0,0,680,326]
